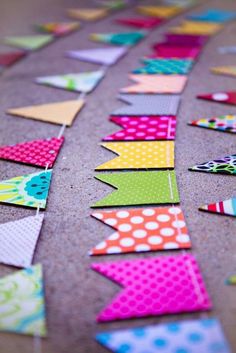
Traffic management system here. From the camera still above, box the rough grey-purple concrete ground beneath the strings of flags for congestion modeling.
[0,0,236,353]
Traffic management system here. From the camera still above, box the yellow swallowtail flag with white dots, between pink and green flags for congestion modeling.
[95,141,174,170]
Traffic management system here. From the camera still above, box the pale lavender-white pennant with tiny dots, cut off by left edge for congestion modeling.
[0,214,44,267]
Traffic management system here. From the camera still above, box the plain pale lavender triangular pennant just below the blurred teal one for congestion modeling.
[67,47,127,65]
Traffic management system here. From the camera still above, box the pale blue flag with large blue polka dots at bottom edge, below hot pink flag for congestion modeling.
[96,318,231,353]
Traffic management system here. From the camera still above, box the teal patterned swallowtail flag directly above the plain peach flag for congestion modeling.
[133,58,193,75]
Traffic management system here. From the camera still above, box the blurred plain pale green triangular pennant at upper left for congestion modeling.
[4,34,53,50]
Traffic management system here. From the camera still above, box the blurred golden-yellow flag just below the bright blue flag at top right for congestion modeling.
[169,21,223,36]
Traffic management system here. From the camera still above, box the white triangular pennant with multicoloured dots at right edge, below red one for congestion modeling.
[189,115,236,134]
